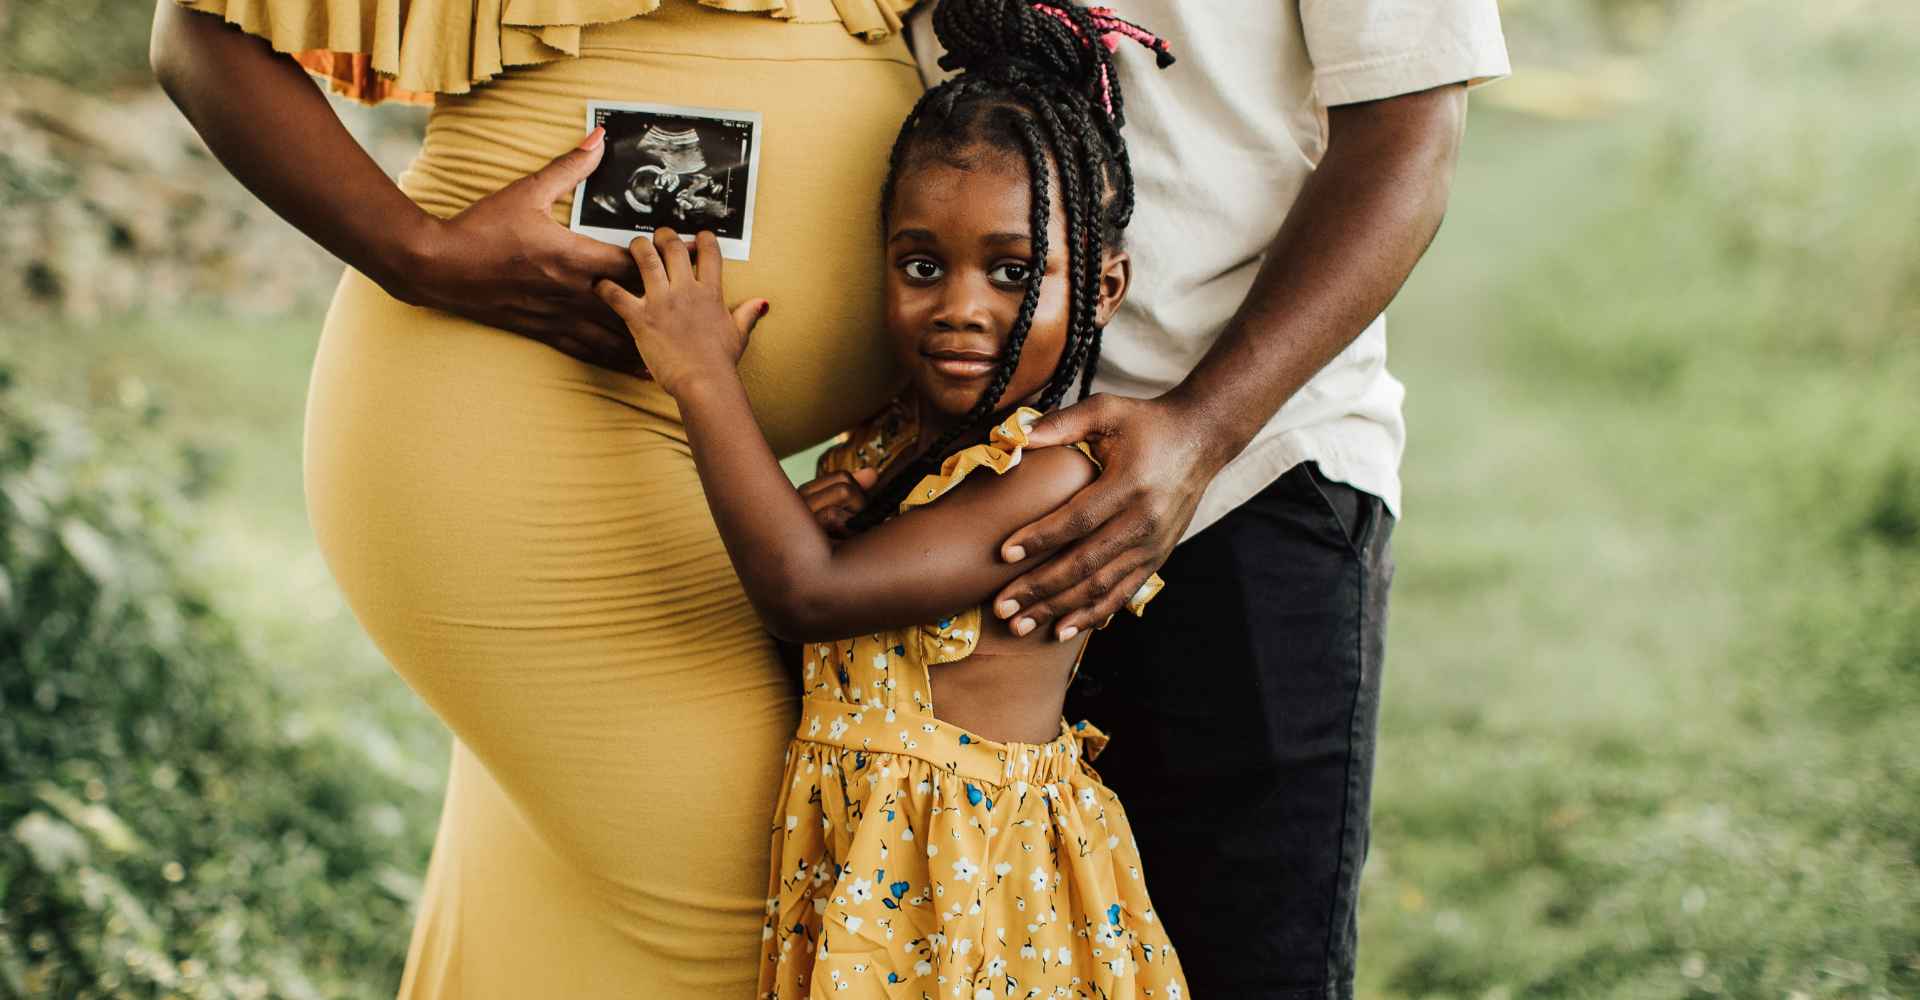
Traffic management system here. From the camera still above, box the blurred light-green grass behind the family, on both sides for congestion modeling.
[0,4,1920,1000]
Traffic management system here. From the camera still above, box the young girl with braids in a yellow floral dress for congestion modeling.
[599,0,1185,1000]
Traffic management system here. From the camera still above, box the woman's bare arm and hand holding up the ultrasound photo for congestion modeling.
[152,0,641,372]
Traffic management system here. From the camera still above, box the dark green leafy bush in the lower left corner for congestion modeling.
[0,376,424,1000]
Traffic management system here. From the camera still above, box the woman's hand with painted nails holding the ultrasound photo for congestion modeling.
[393,129,647,374]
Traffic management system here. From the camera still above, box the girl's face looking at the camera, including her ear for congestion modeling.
[885,150,1127,430]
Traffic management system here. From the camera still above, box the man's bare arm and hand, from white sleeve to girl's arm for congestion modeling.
[995,84,1467,635]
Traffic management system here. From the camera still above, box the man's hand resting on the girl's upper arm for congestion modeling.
[993,393,1225,639]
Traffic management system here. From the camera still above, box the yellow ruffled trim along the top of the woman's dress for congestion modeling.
[175,0,914,104]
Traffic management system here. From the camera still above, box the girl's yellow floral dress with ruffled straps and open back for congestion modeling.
[760,403,1187,1000]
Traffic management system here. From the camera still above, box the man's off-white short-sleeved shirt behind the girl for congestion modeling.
[910,0,1509,537]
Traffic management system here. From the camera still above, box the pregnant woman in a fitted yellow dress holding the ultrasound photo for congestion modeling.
[154,0,920,1000]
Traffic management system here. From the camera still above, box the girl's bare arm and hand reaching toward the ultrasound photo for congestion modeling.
[599,228,1094,641]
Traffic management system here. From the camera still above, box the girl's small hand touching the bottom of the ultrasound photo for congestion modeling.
[593,228,768,397]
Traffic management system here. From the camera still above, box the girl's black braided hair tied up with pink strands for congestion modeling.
[854,0,1173,528]
